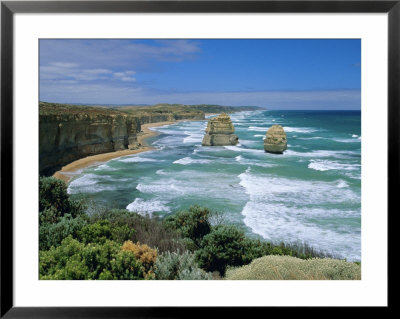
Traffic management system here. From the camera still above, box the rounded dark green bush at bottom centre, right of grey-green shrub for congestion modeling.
[196,226,247,274]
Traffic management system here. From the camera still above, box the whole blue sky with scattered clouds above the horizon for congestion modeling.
[40,39,361,110]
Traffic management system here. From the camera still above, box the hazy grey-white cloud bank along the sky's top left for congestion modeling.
[40,39,200,70]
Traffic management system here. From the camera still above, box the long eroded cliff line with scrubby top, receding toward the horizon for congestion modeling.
[39,102,204,175]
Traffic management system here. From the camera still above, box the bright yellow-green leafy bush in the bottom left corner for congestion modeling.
[39,236,144,280]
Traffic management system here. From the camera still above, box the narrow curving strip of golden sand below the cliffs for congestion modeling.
[53,121,178,183]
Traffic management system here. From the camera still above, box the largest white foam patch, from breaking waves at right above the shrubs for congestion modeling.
[239,172,360,260]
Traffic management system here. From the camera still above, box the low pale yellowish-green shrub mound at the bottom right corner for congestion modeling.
[225,256,361,280]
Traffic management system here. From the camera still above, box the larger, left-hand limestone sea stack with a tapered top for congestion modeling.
[201,113,239,146]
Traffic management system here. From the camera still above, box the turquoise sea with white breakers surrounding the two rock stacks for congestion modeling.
[68,111,361,260]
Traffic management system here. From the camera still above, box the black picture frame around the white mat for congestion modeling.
[0,0,394,318]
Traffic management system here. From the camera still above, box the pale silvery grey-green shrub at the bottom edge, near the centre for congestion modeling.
[154,252,212,280]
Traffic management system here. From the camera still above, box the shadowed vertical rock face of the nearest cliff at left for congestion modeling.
[39,110,140,175]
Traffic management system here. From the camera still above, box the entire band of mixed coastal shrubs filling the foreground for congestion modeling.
[39,177,361,280]
